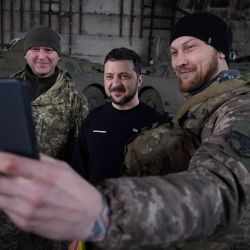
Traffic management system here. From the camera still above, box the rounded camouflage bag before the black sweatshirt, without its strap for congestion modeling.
[123,123,200,176]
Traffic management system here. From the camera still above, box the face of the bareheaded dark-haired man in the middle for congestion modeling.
[104,60,143,109]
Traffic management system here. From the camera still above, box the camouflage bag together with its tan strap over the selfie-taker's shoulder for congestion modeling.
[124,79,249,176]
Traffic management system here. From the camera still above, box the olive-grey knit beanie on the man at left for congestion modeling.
[24,25,60,55]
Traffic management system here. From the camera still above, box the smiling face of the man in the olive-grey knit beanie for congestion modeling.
[24,47,60,77]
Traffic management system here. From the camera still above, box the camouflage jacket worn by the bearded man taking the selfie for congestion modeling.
[98,76,250,250]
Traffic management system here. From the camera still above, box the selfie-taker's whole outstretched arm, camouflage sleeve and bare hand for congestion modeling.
[0,96,250,250]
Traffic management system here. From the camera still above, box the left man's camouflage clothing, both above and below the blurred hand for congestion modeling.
[0,69,88,250]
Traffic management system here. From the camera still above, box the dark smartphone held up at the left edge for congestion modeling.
[0,78,39,159]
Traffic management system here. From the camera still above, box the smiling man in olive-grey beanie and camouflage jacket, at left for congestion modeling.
[0,26,88,250]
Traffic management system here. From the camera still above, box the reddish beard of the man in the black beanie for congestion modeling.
[179,51,218,93]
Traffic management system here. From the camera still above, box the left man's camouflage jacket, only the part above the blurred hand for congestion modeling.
[12,68,89,159]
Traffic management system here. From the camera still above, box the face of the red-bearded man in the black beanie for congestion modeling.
[170,36,220,93]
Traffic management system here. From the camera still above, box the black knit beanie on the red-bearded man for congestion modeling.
[170,12,233,63]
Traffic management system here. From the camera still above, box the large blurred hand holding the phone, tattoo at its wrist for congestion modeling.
[0,153,108,241]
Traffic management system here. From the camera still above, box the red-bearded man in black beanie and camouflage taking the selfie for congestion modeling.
[0,13,250,250]
